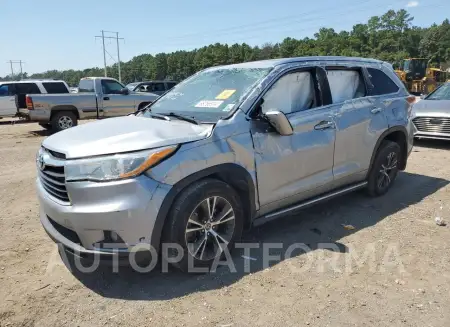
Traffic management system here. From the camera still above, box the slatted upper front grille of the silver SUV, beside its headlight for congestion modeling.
[39,166,69,202]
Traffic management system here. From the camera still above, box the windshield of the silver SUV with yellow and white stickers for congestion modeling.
[144,67,271,122]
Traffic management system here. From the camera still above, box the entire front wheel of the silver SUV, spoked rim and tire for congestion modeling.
[163,179,244,272]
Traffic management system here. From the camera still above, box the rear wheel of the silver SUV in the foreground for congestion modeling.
[367,141,402,196]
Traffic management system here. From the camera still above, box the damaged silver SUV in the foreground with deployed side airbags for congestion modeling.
[36,57,414,270]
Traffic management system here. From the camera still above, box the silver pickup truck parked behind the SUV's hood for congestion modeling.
[17,77,159,132]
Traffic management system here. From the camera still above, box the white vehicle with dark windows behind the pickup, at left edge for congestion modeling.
[0,80,69,118]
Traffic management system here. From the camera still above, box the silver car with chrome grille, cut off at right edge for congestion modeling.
[412,82,450,140]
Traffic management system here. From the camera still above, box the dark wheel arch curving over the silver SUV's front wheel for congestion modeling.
[151,163,256,250]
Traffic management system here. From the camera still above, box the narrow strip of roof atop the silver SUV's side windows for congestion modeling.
[211,56,383,68]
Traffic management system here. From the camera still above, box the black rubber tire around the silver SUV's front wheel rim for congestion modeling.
[161,179,244,272]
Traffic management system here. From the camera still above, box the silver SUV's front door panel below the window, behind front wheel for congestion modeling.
[251,106,335,211]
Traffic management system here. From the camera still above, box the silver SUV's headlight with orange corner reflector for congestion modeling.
[64,145,178,182]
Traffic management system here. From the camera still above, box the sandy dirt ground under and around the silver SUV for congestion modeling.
[0,121,450,327]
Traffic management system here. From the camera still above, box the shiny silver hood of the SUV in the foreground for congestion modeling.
[42,115,214,159]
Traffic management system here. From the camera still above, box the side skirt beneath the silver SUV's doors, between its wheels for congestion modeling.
[253,182,367,226]
